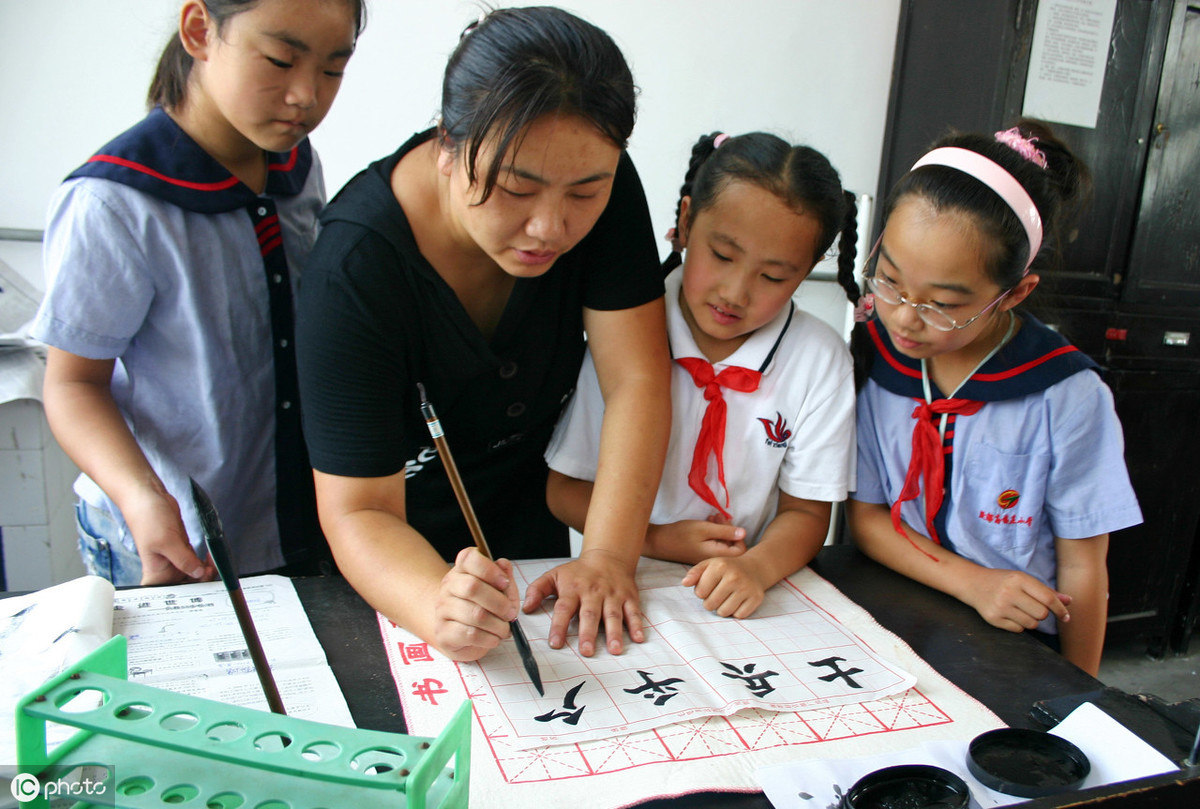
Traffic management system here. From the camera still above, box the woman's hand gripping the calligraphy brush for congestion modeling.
[433,547,521,661]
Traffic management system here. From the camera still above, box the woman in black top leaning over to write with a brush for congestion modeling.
[298,7,671,660]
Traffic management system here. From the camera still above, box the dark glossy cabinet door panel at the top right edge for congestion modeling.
[1122,0,1200,306]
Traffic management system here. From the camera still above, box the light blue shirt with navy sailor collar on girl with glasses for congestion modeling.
[853,314,1141,633]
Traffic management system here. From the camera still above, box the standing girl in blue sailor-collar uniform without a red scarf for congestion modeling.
[32,0,362,585]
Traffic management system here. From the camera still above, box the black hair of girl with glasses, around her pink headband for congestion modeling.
[883,119,1091,289]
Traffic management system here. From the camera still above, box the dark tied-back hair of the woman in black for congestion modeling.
[438,6,637,202]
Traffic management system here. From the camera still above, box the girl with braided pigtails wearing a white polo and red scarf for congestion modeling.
[546,132,857,618]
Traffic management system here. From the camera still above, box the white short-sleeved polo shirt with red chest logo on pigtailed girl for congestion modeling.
[546,268,854,545]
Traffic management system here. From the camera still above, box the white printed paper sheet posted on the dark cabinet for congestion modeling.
[1021,0,1117,128]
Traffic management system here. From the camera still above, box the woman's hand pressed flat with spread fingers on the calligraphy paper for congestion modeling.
[524,550,646,658]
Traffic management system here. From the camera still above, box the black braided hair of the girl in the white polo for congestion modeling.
[662,132,862,297]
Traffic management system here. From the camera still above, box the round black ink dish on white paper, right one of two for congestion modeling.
[967,727,1092,798]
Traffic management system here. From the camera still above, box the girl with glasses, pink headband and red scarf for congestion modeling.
[847,121,1141,675]
